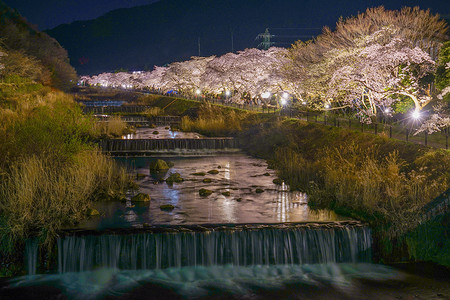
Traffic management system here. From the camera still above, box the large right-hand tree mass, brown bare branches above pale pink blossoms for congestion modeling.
[283,7,448,122]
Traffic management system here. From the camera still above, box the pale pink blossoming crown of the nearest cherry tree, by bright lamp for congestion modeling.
[325,27,435,122]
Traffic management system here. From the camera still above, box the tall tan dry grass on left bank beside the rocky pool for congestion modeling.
[0,151,129,249]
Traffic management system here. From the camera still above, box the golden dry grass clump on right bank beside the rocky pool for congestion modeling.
[292,143,450,238]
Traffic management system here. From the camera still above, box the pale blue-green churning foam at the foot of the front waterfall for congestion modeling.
[7,263,405,300]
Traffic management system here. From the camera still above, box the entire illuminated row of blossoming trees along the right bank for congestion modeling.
[81,7,450,132]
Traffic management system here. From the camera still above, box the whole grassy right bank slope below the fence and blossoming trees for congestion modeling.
[241,119,450,263]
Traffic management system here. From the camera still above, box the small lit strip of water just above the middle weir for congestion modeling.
[122,126,204,140]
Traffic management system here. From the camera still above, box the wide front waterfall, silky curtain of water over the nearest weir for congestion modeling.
[57,225,372,273]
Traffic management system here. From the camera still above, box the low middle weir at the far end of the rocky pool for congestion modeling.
[99,138,239,155]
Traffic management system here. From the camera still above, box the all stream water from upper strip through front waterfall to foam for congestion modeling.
[0,132,450,300]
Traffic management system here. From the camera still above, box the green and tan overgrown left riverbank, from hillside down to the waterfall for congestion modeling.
[0,29,130,276]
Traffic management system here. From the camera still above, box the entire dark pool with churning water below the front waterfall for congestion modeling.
[4,263,450,300]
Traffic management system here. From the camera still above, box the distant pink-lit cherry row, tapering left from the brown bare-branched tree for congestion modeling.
[80,47,286,103]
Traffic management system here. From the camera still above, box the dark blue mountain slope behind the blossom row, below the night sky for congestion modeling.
[47,0,448,74]
